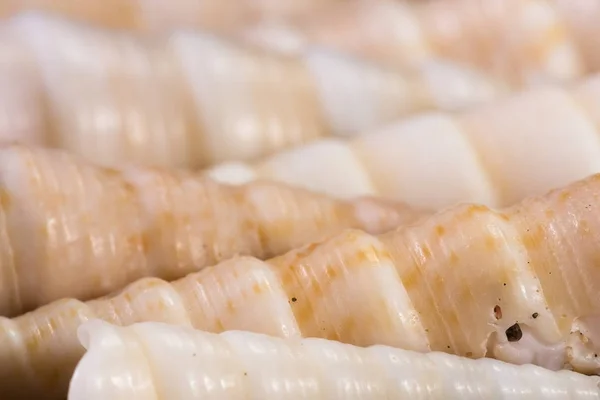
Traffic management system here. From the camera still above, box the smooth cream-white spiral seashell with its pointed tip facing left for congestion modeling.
[207,75,600,209]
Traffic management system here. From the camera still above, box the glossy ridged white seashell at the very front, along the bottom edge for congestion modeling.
[68,320,600,400]
